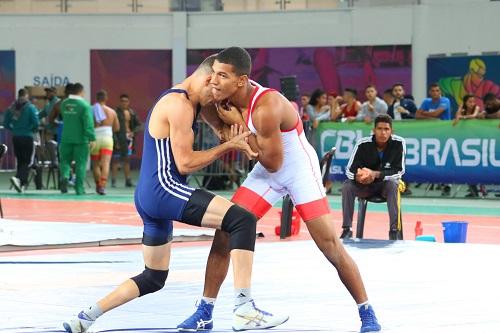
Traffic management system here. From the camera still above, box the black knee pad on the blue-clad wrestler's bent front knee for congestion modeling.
[221,205,257,251]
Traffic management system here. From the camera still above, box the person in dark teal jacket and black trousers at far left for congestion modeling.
[3,89,39,193]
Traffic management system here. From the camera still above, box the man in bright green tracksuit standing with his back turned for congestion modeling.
[59,83,95,195]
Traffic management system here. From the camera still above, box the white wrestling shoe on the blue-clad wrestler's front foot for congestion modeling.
[233,301,289,331]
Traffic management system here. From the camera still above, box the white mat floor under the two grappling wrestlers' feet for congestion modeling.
[0,241,500,333]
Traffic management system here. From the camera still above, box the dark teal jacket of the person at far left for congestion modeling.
[3,101,39,137]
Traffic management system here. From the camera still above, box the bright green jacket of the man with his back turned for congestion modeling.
[61,95,95,144]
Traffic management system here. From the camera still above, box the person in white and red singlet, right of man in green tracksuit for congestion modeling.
[90,90,120,195]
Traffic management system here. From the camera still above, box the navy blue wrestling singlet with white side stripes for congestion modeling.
[134,89,197,246]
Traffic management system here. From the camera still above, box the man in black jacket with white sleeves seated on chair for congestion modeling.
[340,115,406,239]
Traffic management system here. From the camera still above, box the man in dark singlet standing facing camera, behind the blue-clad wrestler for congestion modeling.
[111,94,141,187]
